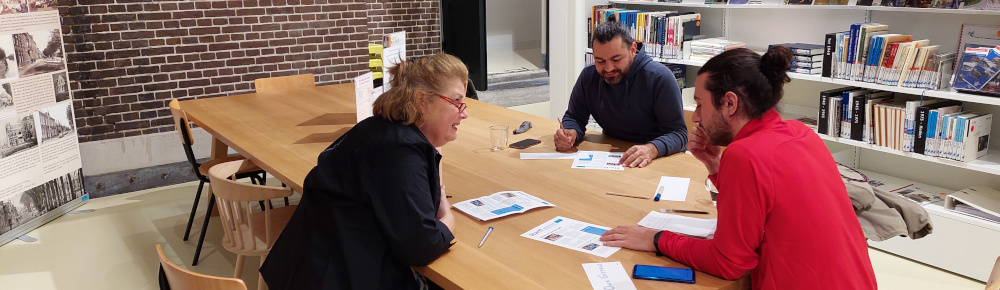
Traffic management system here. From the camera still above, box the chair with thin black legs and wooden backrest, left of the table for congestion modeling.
[169,99,268,266]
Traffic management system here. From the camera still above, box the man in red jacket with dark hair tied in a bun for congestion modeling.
[601,47,876,289]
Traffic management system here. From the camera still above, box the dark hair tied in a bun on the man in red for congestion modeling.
[698,46,792,119]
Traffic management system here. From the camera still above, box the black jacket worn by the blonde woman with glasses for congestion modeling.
[260,117,454,290]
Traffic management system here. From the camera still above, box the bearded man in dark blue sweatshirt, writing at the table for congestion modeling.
[554,21,687,167]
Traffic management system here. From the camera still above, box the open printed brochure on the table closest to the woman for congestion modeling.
[452,191,556,221]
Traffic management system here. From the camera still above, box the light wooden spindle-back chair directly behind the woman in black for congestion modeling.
[208,160,296,289]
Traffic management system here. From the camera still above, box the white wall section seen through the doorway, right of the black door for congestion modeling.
[486,0,543,53]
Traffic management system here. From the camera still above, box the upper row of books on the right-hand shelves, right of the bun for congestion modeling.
[823,23,955,90]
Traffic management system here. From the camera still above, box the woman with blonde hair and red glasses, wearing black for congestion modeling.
[260,54,468,289]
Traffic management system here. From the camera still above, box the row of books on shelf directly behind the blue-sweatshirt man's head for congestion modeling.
[588,5,701,59]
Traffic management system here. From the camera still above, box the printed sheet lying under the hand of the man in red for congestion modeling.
[521,216,621,258]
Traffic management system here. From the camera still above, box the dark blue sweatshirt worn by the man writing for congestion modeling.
[562,43,687,157]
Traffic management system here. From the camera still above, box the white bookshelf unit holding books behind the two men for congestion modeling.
[564,0,1000,281]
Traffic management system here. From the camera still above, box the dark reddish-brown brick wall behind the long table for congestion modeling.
[60,0,440,142]
